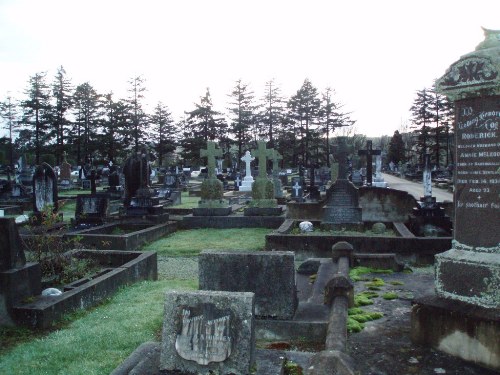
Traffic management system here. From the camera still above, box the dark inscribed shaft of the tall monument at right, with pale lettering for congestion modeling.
[455,96,500,248]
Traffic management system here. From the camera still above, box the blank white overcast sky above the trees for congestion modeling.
[0,0,500,136]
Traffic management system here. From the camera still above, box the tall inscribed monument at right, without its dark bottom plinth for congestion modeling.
[436,30,500,309]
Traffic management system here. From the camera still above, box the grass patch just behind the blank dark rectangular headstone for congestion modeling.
[141,228,272,256]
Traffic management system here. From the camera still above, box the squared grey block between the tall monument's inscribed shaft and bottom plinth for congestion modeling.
[435,249,500,309]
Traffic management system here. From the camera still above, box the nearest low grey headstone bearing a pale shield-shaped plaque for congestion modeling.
[160,290,255,375]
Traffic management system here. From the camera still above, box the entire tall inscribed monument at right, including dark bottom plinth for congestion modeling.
[412,29,500,370]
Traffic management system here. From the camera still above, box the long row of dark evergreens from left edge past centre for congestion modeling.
[0,66,354,169]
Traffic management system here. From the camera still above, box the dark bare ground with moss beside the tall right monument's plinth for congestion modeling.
[347,267,498,375]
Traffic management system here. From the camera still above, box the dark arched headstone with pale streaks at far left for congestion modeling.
[33,163,59,214]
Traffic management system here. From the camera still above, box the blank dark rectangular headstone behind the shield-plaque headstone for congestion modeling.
[199,250,297,319]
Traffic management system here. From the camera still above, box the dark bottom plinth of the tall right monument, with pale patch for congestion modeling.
[411,296,500,371]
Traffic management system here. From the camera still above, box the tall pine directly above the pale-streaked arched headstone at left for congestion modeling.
[21,73,51,164]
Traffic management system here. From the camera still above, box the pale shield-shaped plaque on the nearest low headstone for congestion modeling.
[175,304,232,365]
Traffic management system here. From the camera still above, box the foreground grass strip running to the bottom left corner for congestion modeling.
[0,280,197,375]
